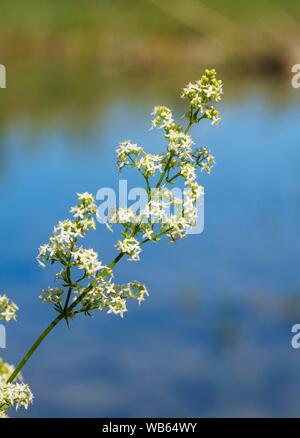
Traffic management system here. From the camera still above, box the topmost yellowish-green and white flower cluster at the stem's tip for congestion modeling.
[181,69,223,125]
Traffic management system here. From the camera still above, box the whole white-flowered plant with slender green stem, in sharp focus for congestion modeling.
[0,70,223,417]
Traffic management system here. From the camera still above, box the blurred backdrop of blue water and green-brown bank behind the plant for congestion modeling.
[0,0,300,417]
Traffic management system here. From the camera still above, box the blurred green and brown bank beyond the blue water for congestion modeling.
[0,0,300,124]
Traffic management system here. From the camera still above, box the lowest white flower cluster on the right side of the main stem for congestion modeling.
[77,278,148,318]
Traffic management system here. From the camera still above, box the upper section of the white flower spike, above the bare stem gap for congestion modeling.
[109,70,223,246]
